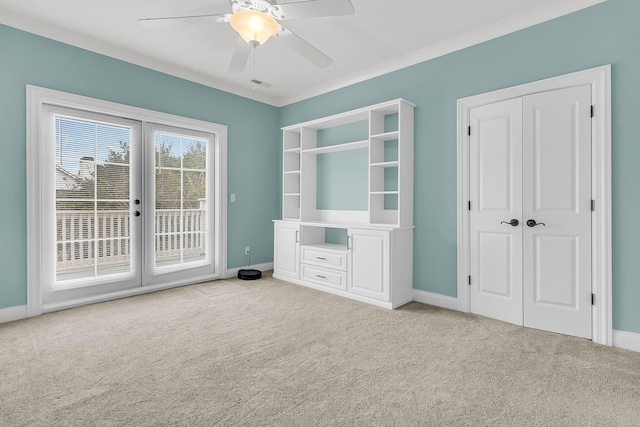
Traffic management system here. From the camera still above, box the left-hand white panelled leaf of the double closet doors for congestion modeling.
[470,98,522,325]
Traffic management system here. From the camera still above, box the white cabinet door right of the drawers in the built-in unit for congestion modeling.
[349,228,390,301]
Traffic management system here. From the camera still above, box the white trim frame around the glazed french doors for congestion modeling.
[26,85,227,317]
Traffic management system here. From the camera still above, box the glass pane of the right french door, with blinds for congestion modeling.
[154,131,208,267]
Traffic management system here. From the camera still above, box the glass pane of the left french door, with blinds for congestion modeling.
[54,115,133,284]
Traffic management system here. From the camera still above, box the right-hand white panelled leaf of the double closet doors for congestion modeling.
[524,86,591,338]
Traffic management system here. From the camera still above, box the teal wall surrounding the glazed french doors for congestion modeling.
[0,25,280,309]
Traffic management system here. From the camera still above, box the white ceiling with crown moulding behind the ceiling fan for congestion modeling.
[0,0,605,106]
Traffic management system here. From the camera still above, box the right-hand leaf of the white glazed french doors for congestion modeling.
[142,123,216,285]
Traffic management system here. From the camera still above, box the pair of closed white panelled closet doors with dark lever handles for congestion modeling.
[469,85,592,338]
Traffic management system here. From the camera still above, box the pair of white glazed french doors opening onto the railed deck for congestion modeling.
[40,101,221,309]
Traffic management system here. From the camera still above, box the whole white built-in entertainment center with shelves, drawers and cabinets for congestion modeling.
[273,99,415,308]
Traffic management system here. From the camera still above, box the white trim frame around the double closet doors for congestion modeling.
[457,65,613,346]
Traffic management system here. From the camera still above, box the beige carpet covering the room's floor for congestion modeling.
[0,277,640,427]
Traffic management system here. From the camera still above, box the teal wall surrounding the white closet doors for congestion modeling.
[280,0,640,333]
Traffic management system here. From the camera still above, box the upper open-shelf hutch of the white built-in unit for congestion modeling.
[282,99,415,227]
